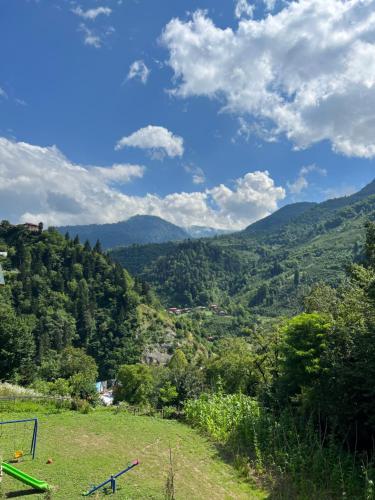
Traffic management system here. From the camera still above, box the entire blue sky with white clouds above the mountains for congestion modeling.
[0,0,375,229]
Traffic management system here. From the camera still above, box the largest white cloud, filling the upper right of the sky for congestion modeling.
[162,0,375,158]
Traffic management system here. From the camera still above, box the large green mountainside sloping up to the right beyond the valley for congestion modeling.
[111,182,375,315]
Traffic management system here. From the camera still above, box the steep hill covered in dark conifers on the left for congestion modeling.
[0,221,189,381]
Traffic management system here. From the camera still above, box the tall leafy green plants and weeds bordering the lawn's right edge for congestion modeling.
[185,394,373,499]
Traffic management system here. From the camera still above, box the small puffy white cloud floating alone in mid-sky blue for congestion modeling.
[115,125,184,158]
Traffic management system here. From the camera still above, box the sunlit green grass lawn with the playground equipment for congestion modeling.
[0,409,267,500]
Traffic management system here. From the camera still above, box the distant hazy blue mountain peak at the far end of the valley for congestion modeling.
[57,215,189,249]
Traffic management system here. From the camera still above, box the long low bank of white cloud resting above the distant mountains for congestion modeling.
[0,138,285,229]
